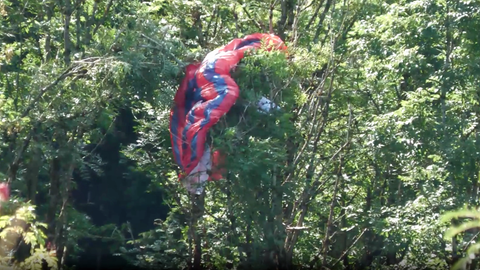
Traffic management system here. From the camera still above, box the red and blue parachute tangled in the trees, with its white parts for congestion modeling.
[170,33,287,194]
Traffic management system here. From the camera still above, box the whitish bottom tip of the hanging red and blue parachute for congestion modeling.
[182,146,212,195]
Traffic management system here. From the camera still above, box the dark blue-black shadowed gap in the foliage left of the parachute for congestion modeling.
[67,109,168,269]
